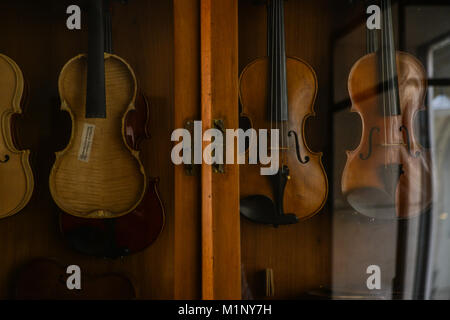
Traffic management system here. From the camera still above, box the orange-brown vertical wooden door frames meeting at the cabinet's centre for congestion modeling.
[174,0,241,300]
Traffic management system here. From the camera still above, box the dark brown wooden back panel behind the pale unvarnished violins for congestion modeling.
[0,0,175,299]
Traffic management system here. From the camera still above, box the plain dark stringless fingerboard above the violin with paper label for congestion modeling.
[86,0,106,119]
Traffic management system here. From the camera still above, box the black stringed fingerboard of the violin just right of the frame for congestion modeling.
[267,0,288,121]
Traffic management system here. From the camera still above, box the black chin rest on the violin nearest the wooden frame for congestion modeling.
[240,195,298,227]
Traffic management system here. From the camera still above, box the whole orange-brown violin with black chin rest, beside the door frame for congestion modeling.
[239,0,328,226]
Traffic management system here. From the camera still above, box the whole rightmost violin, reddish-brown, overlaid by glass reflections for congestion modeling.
[342,0,432,219]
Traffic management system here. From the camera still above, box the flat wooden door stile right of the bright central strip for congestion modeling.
[208,0,241,300]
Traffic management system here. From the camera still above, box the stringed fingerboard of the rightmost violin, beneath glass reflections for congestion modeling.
[379,0,401,116]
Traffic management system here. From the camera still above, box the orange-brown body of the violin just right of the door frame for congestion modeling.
[240,57,328,219]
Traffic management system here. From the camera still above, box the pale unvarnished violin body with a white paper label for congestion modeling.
[50,53,147,218]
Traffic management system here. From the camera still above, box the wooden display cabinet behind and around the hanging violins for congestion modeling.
[0,0,436,299]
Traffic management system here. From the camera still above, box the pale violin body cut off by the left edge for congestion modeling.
[0,54,34,218]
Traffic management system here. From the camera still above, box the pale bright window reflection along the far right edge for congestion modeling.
[428,37,450,299]
